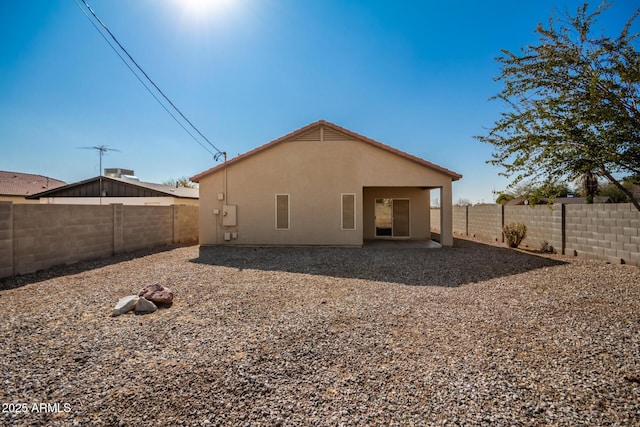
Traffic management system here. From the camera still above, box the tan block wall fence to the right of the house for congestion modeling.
[431,203,640,266]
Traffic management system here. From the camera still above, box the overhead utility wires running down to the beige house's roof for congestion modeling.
[74,0,226,160]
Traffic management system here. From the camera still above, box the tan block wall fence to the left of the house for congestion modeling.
[0,202,198,277]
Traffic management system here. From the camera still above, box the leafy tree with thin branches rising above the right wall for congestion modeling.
[476,1,640,211]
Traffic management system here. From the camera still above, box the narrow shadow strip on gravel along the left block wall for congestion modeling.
[0,245,182,291]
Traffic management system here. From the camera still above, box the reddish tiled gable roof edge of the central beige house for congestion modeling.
[189,120,462,182]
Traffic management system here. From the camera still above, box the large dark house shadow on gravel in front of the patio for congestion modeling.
[191,239,564,287]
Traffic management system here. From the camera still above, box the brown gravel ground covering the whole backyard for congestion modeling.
[0,239,640,426]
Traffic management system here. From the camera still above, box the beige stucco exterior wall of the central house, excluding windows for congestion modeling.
[200,127,451,246]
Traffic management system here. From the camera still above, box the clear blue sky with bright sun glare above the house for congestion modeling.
[0,0,636,203]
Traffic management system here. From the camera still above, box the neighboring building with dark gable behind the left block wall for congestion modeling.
[28,175,198,206]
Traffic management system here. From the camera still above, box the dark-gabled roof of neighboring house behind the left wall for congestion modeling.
[27,176,199,199]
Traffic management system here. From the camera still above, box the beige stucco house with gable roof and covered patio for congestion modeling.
[191,120,462,246]
